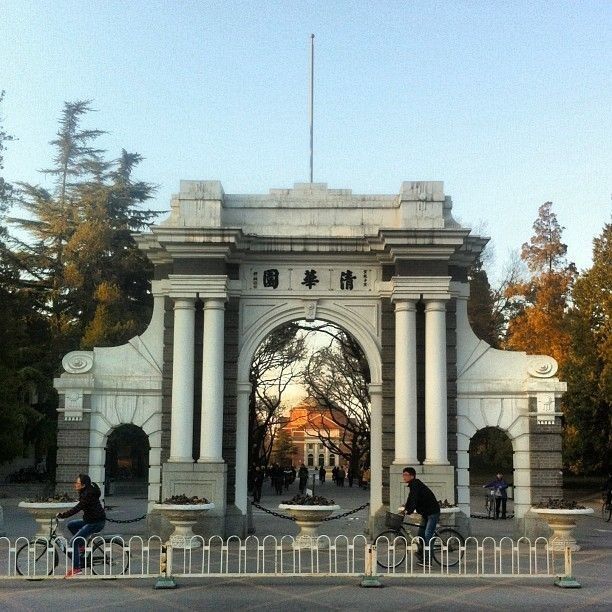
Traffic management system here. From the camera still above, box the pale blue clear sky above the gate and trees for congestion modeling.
[0,0,612,276]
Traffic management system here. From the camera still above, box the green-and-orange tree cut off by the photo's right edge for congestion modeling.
[562,223,612,474]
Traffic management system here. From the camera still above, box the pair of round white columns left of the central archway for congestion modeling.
[168,297,225,463]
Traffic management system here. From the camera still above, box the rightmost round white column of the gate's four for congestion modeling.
[425,300,448,465]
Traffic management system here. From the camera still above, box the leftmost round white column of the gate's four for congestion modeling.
[168,298,195,463]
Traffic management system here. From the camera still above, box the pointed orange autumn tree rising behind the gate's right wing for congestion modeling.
[504,202,576,365]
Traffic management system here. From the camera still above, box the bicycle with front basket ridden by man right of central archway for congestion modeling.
[374,512,465,569]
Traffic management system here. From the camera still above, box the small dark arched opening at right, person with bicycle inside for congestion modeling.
[469,427,514,519]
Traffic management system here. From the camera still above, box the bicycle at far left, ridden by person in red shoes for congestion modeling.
[15,519,130,576]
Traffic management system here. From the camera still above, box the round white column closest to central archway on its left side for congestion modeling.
[198,298,225,463]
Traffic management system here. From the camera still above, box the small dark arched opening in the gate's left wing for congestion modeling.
[105,423,150,495]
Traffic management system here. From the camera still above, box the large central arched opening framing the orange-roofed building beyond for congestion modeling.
[248,319,371,530]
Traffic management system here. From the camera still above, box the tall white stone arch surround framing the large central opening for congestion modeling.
[235,299,382,515]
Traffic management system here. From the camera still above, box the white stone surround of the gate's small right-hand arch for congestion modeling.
[457,397,531,518]
